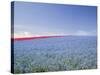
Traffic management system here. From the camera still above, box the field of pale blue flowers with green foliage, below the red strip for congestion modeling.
[14,36,97,73]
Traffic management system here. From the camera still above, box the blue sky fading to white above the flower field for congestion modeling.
[14,2,97,36]
